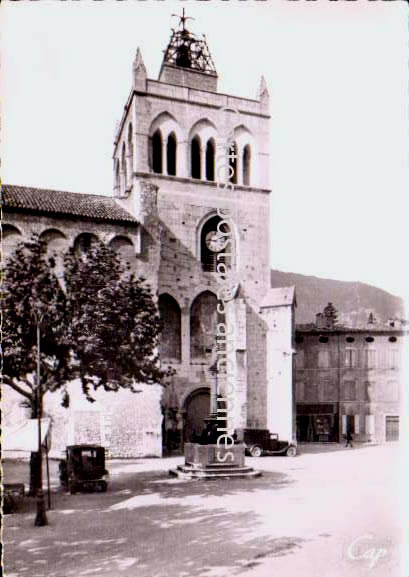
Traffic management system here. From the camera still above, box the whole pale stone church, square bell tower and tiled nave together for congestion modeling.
[2,20,295,457]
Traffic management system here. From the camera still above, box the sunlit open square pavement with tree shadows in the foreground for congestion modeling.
[3,444,409,577]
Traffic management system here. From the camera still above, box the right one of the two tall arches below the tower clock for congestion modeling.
[190,291,217,362]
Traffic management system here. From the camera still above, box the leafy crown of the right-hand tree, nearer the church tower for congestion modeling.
[64,243,169,401]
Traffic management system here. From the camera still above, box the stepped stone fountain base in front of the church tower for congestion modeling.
[169,443,261,479]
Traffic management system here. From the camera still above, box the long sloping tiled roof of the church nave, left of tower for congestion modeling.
[1,184,137,223]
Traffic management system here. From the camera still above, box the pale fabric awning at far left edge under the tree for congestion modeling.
[1,419,51,453]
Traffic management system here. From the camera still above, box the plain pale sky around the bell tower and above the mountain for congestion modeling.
[0,0,409,298]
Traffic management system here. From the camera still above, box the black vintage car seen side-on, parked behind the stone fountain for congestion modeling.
[237,429,297,457]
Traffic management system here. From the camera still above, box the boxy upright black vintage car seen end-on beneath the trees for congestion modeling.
[60,445,109,494]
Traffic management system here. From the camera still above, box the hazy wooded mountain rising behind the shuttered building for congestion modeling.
[271,270,405,327]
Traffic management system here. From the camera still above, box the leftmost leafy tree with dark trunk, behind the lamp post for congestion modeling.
[2,238,72,494]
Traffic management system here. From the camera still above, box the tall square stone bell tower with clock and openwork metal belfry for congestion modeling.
[114,11,293,441]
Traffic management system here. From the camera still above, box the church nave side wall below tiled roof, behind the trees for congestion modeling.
[3,209,162,458]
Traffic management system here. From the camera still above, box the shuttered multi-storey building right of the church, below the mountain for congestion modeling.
[296,313,408,443]
